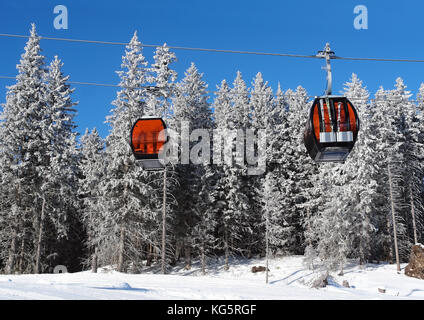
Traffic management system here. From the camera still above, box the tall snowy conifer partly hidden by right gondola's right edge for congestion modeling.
[336,74,378,264]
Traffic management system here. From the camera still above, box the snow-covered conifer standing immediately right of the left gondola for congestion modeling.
[171,63,212,268]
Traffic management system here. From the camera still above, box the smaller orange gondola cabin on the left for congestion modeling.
[131,117,166,170]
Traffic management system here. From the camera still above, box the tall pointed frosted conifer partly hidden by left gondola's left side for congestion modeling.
[99,33,152,271]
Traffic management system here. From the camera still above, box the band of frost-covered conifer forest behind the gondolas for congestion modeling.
[0,25,424,273]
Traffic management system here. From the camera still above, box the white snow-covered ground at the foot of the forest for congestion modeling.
[0,256,424,300]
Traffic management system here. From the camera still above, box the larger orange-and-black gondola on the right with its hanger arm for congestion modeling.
[303,43,359,163]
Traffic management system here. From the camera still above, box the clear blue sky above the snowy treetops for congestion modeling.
[0,0,424,137]
